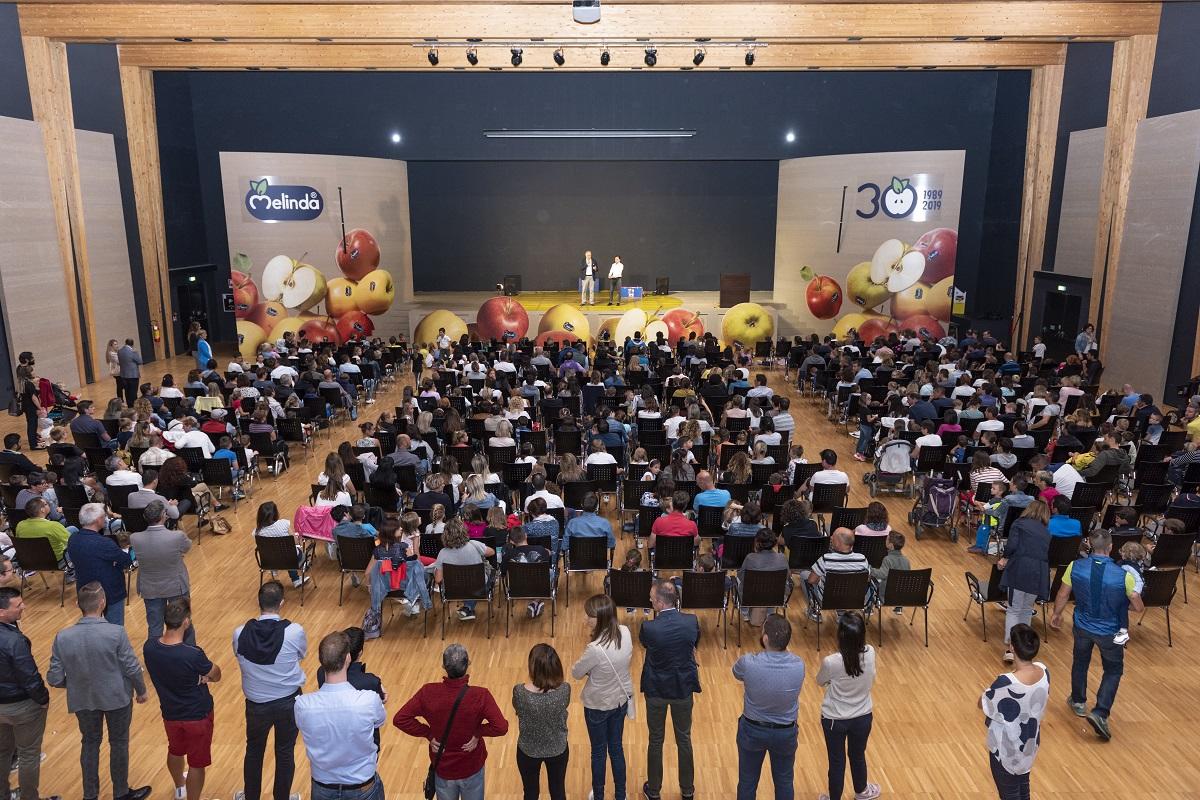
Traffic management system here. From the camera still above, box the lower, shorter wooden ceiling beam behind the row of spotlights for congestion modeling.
[120,42,1066,72]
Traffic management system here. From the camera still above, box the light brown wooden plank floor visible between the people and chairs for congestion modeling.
[11,359,1200,800]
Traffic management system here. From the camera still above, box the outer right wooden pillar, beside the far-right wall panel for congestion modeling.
[1088,35,1158,361]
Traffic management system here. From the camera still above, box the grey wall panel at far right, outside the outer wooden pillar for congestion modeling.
[1104,110,1200,397]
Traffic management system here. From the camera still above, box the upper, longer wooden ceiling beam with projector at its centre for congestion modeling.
[19,0,1159,42]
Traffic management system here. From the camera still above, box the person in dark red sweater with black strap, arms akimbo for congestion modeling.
[392,644,509,800]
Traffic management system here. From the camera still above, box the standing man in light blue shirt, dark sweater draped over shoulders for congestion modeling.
[233,581,308,800]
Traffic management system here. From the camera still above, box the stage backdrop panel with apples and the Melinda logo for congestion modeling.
[221,152,413,353]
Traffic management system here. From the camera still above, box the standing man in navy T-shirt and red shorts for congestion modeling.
[142,597,221,800]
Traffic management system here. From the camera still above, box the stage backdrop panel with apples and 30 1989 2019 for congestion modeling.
[775,150,964,339]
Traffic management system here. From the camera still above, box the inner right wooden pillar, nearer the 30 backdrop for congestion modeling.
[1013,64,1063,349]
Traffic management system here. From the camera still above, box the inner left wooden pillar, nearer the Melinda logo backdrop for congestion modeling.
[121,65,174,359]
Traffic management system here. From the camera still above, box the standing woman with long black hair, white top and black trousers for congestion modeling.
[817,612,880,800]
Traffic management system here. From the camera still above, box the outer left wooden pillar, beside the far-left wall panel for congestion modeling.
[22,36,98,383]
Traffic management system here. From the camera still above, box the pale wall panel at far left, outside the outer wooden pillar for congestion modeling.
[0,116,83,386]
